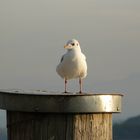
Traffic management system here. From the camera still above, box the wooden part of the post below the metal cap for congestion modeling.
[7,111,112,140]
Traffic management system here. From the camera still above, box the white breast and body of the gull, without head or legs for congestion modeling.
[56,50,87,79]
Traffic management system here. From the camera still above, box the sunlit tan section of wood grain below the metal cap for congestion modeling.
[74,113,112,140]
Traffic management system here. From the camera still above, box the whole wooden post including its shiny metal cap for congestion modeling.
[0,90,122,140]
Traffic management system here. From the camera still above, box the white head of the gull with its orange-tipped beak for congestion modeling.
[64,39,80,50]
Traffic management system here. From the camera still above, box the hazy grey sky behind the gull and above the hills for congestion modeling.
[0,0,140,127]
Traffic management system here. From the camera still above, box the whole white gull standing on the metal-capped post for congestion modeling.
[56,39,87,93]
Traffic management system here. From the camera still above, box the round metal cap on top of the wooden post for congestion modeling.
[0,90,122,113]
